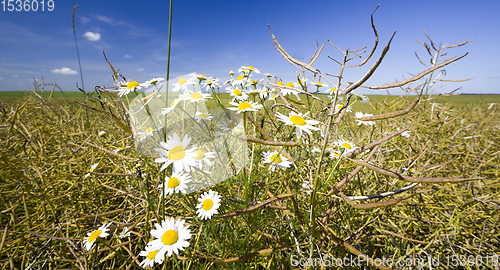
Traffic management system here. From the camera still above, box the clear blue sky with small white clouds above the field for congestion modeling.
[0,0,500,94]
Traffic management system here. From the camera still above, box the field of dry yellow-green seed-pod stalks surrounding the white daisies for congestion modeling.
[0,6,500,269]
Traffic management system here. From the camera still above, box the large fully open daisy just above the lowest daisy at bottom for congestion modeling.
[149,217,191,258]
